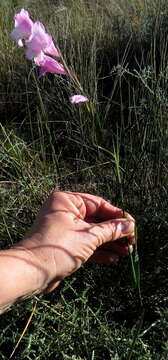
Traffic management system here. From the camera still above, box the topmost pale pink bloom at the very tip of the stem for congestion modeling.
[11,9,33,47]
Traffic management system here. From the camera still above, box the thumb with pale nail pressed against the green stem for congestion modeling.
[92,219,135,246]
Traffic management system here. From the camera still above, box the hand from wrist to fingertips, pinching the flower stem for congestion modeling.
[19,191,135,292]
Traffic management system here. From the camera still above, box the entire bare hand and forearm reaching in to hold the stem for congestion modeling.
[0,191,135,312]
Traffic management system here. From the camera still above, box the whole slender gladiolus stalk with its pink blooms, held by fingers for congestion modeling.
[11,9,142,306]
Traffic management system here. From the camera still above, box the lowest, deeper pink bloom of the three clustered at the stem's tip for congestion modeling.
[34,53,68,76]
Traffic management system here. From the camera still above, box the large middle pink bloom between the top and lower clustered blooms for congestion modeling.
[25,21,60,60]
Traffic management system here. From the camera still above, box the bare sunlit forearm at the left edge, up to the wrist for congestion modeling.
[0,247,48,313]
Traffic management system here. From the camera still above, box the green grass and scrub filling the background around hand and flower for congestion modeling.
[0,0,168,360]
